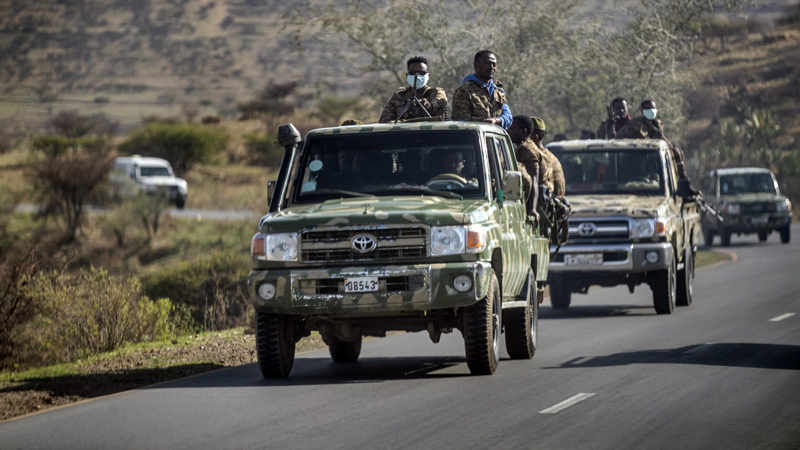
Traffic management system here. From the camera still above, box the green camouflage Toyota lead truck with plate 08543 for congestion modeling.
[248,122,549,378]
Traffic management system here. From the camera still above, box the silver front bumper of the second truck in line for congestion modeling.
[550,242,675,273]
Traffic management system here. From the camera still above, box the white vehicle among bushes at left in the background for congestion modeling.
[109,155,189,209]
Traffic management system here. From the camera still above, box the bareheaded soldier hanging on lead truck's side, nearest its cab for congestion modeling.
[508,115,544,220]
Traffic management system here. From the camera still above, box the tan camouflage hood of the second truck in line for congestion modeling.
[569,195,667,217]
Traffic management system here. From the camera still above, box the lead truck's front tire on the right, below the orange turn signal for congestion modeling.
[464,273,503,375]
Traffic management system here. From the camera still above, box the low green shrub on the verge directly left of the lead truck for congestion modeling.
[141,252,250,329]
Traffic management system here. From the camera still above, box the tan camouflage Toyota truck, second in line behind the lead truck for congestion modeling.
[548,140,700,314]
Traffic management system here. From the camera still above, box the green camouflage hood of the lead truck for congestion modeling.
[259,197,493,232]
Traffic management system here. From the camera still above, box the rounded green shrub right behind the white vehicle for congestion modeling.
[119,122,228,175]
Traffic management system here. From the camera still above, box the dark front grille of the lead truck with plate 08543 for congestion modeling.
[300,227,428,262]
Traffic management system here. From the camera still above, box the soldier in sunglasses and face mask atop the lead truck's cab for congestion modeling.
[378,56,447,123]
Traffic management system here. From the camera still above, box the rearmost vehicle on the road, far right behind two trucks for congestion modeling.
[702,167,792,246]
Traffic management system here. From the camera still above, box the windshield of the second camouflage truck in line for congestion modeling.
[554,150,665,195]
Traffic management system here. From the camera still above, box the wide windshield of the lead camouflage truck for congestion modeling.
[294,130,485,203]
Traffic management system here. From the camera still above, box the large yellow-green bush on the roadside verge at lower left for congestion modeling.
[26,267,187,362]
